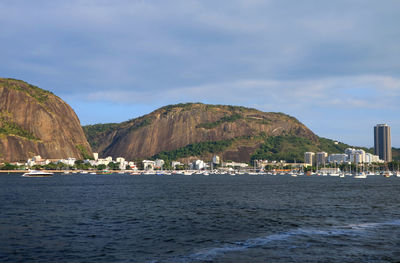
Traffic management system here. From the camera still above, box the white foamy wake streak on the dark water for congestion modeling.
[182,220,400,262]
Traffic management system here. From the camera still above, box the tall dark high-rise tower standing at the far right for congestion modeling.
[374,124,392,162]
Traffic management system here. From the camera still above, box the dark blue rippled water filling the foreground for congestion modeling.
[0,175,400,262]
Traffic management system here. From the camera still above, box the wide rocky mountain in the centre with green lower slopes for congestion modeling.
[83,103,324,161]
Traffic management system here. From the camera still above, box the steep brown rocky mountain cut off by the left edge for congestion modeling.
[0,78,92,161]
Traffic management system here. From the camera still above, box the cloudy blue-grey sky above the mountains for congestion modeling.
[0,0,400,147]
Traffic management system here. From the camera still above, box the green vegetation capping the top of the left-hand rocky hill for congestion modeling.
[0,78,53,103]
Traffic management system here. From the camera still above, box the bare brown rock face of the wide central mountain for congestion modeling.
[84,103,318,160]
